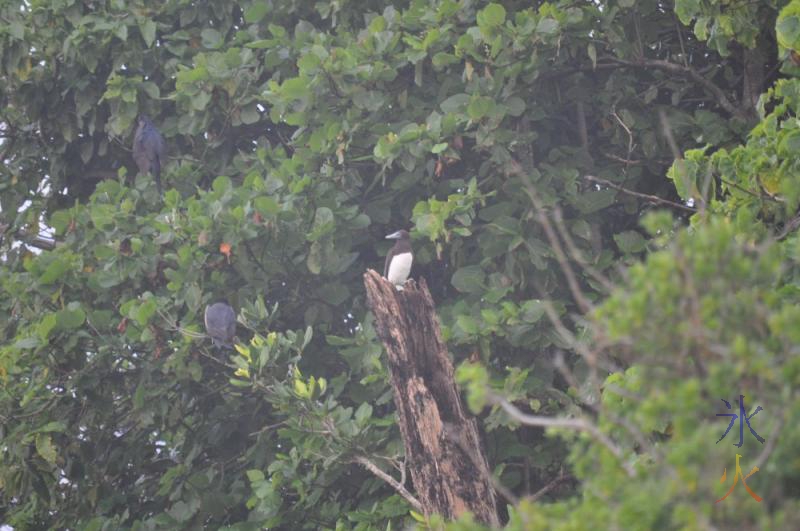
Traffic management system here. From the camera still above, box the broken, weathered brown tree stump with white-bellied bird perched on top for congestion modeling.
[364,270,499,525]
